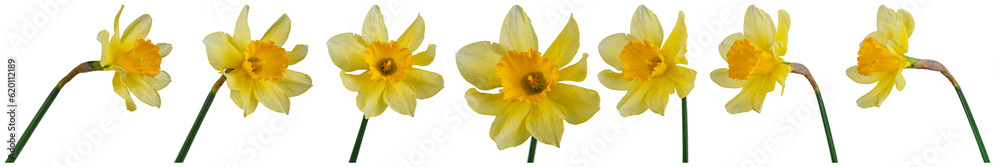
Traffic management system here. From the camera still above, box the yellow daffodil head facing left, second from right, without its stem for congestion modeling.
[711,5,792,114]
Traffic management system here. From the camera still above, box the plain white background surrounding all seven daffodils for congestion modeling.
[0,0,1000,166]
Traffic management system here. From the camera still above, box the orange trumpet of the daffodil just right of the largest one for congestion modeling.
[618,40,667,81]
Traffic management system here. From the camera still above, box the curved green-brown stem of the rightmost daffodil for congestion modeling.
[913,59,990,163]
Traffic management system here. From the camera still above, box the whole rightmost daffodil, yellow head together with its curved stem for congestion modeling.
[846,5,990,163]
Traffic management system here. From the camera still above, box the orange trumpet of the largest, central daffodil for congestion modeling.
[495,50,559,104]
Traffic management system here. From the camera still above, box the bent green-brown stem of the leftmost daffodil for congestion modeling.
[6,61,103,163]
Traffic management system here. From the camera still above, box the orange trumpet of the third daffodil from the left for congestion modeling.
[363,41,413,83]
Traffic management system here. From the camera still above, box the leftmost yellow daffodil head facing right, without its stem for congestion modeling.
[97,5,173,111]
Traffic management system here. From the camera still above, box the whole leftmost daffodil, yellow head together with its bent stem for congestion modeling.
[7,5,173,163]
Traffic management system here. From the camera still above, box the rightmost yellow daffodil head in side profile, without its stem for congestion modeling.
[847,5,919,108]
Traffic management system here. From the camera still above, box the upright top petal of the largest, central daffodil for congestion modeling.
[500,5,540,51]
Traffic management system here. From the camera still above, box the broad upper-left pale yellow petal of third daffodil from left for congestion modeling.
[326,33,368,71]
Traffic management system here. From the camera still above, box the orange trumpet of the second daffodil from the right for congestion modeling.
[726,39,777,80]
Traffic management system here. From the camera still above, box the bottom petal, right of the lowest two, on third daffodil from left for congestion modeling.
[382,83,417,117]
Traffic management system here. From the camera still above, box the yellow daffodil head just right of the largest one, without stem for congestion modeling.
[598,5,697,117]
